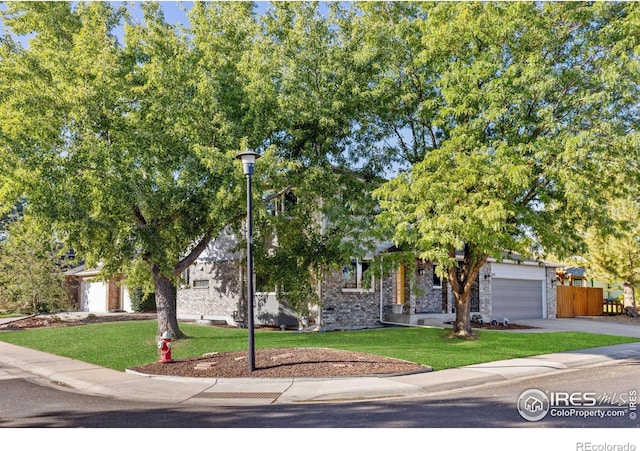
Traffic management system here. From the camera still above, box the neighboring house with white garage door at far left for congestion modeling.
[65,265,133,313]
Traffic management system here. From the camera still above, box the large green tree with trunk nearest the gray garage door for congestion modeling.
[368,2,638,336]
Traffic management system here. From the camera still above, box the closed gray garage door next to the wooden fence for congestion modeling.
[491,279,542,320]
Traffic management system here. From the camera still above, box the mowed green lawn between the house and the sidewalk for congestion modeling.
[0,320,640,371]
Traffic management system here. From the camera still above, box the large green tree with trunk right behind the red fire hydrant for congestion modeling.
[0,2,261,337]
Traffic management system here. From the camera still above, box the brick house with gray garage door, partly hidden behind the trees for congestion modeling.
[177,234,557,330]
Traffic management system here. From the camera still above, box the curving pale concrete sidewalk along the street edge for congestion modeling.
[0,342,640,406]
